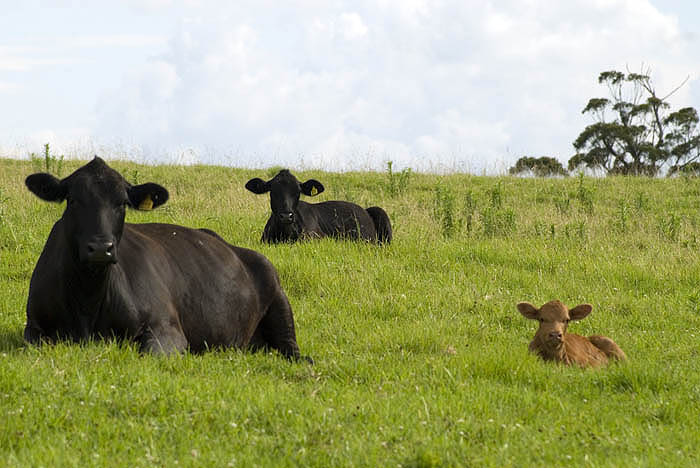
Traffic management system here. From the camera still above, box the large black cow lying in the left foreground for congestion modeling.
[24,157,308,359]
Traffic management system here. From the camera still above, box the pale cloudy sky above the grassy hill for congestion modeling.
[0,0,700,174]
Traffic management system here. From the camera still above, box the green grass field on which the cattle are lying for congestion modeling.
[0,159,700,467]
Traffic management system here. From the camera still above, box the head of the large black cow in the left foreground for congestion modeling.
[25,156,168,266]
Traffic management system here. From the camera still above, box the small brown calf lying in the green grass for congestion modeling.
[517,300,627,367]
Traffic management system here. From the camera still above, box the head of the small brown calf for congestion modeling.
[517,300,593,348]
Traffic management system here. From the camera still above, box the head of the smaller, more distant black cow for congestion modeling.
[245,169,324,225]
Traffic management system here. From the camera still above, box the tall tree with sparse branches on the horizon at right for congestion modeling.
[568,69,700,176]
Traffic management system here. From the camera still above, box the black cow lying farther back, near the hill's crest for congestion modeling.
[245,169,392,244]
